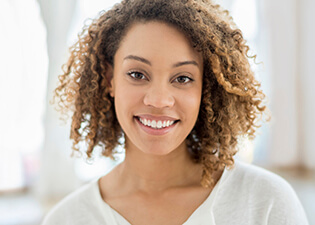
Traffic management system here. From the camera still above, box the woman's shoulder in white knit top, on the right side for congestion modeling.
[217,161,307,225]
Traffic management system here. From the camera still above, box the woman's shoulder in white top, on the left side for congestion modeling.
[43,180,107,225]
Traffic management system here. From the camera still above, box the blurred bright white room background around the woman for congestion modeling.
[0,0,315,225]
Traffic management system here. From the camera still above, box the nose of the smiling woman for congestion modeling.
[143,84,175,108]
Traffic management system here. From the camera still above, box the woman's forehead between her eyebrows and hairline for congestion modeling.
[115,21,203,65]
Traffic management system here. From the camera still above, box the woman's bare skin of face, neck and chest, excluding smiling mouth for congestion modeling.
[99,22,222,224]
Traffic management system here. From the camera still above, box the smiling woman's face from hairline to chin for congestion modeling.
[111,22,203,155]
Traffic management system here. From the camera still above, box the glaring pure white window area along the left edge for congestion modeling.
[0,0,48,191]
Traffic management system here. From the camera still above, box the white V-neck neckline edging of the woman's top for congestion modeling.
[95,168,227,225]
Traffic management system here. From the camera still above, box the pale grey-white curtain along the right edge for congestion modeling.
[260,0,315,169]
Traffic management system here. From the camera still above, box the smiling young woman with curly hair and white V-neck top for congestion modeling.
[44,0,307,225]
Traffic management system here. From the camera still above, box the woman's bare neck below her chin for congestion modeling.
[119,143,202,193]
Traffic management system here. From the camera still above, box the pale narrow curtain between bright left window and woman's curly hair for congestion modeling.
[34,0,78,199]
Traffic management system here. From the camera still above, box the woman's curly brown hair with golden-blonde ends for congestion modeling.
[54,0,266,187]
